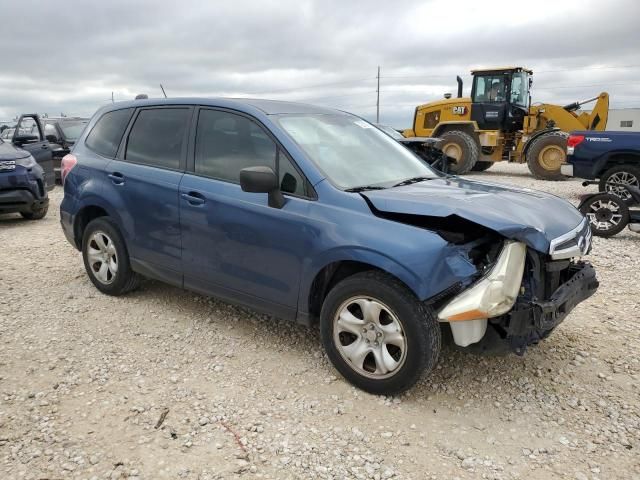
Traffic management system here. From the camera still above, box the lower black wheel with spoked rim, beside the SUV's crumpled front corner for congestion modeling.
[580,193,629,237]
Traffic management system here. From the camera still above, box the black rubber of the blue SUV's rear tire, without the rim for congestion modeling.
[82,217,140,296]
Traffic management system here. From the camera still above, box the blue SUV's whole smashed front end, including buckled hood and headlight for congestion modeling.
[365,185,598,355]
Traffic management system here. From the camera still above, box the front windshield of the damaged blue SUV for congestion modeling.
[277,114,438,190]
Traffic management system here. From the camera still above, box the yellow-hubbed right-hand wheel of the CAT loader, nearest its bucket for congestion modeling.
[527,131,569,180]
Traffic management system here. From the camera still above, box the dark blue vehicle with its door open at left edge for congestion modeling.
[0,114,55,220]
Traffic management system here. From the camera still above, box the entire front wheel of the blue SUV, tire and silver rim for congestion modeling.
[320,270,441,395]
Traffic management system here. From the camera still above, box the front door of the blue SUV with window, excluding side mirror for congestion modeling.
[180,108,310,318]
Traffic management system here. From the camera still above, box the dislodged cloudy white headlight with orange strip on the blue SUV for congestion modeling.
[438,241,527,322]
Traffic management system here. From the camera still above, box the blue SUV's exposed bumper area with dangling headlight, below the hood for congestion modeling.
[434,241,598,355]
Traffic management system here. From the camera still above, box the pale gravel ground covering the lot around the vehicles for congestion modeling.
[0,164,640,480]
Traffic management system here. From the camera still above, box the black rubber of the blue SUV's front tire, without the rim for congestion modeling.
[320,270,441,395]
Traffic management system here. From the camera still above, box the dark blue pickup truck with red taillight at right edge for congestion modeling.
[560,131,640,200]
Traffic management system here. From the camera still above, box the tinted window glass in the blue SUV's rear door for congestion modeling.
[125,108,190,170]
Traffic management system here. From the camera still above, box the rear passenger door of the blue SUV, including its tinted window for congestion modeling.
[106,106,193,286]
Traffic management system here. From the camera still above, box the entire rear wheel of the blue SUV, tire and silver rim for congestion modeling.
[82,217,140,296]
